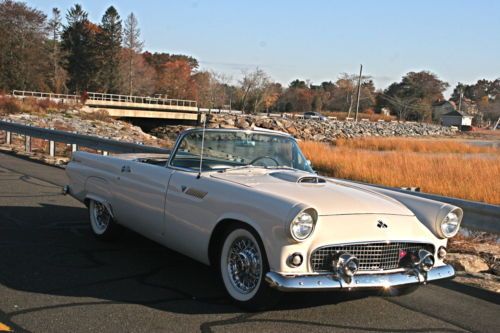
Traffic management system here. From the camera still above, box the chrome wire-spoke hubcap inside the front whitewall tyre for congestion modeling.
[227,237,262,294]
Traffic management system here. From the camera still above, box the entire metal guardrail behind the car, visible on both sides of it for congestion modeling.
[0,120,500,233]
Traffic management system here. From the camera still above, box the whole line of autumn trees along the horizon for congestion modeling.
[0,0,500,121]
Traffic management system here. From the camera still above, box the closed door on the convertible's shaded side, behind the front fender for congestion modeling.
[113,160,173,241]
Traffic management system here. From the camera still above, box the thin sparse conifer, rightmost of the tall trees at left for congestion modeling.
[123,13,144,95]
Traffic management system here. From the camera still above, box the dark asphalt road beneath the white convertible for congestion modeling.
[0,153,500,332]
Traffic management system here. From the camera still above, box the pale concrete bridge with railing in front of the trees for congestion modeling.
[12,90,200,121]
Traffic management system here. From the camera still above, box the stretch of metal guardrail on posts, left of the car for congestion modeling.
[0,120,170,156]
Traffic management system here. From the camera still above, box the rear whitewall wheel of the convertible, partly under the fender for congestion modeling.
[89,200,119,240]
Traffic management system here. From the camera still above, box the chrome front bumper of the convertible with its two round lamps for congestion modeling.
[266,250,455,291]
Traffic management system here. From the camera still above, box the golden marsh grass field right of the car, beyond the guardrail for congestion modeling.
[300,138,500,205]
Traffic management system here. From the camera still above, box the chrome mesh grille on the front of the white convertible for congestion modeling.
[311,242,434,272]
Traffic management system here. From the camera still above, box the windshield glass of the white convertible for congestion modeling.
[170,130,313,172]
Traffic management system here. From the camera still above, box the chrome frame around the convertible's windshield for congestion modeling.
[166,128,314,173]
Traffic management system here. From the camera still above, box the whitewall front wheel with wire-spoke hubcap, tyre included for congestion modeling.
[219,225,277,311]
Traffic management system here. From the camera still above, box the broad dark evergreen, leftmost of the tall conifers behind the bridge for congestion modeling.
[61,4,100,92]
